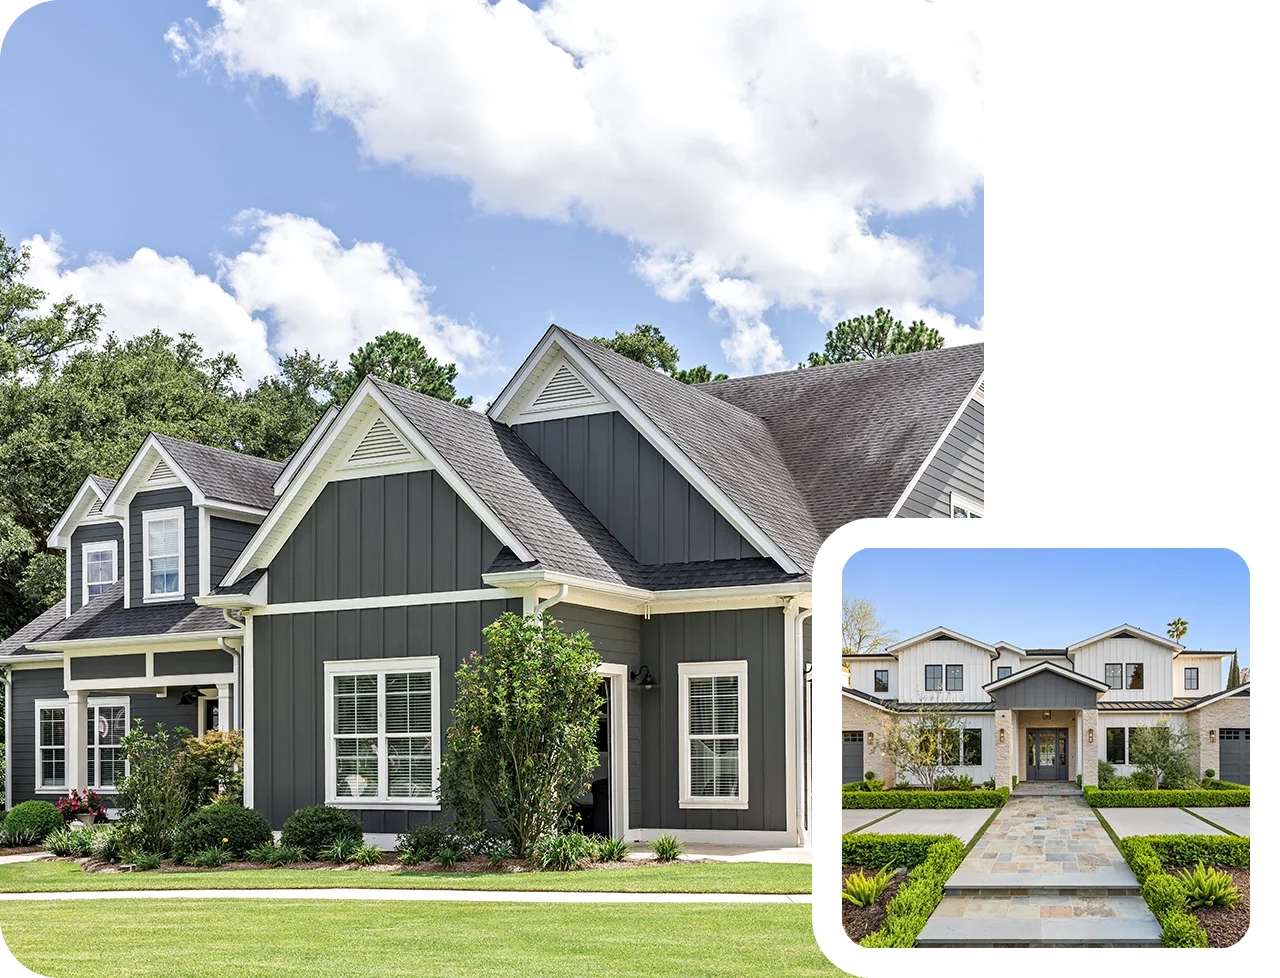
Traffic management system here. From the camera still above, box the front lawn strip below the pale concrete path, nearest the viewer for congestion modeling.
[0,896,844,978]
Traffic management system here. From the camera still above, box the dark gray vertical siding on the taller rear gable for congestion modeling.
[512,411,759,563]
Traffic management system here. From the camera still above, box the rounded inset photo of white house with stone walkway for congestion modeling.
[840,549,1252,947]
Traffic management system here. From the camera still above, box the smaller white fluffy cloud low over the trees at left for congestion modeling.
[23,211,495,383]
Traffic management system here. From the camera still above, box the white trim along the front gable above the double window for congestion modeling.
[220,378,534,585]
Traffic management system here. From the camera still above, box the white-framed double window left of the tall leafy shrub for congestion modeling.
[324,655,440,808]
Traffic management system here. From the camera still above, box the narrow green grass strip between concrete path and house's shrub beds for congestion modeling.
[0,863,812,894]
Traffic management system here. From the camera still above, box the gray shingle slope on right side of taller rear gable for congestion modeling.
[561,330,819,571]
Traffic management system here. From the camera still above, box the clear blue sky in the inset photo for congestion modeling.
[844,549,1249,666]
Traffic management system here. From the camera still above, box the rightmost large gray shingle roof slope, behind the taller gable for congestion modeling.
[698,343,984,540]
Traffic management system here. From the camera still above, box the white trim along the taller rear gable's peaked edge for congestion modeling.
[488,326,804,573]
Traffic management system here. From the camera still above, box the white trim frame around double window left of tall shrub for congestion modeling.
[324,655,440,812]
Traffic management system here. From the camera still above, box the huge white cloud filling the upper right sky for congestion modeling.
[166,0,984,370]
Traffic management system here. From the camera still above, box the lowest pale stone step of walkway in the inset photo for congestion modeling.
[915,917,1161,947]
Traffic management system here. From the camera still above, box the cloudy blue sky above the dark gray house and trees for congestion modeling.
[0,0,983,398]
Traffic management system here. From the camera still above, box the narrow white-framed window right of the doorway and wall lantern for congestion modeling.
[677,661,748,808]
